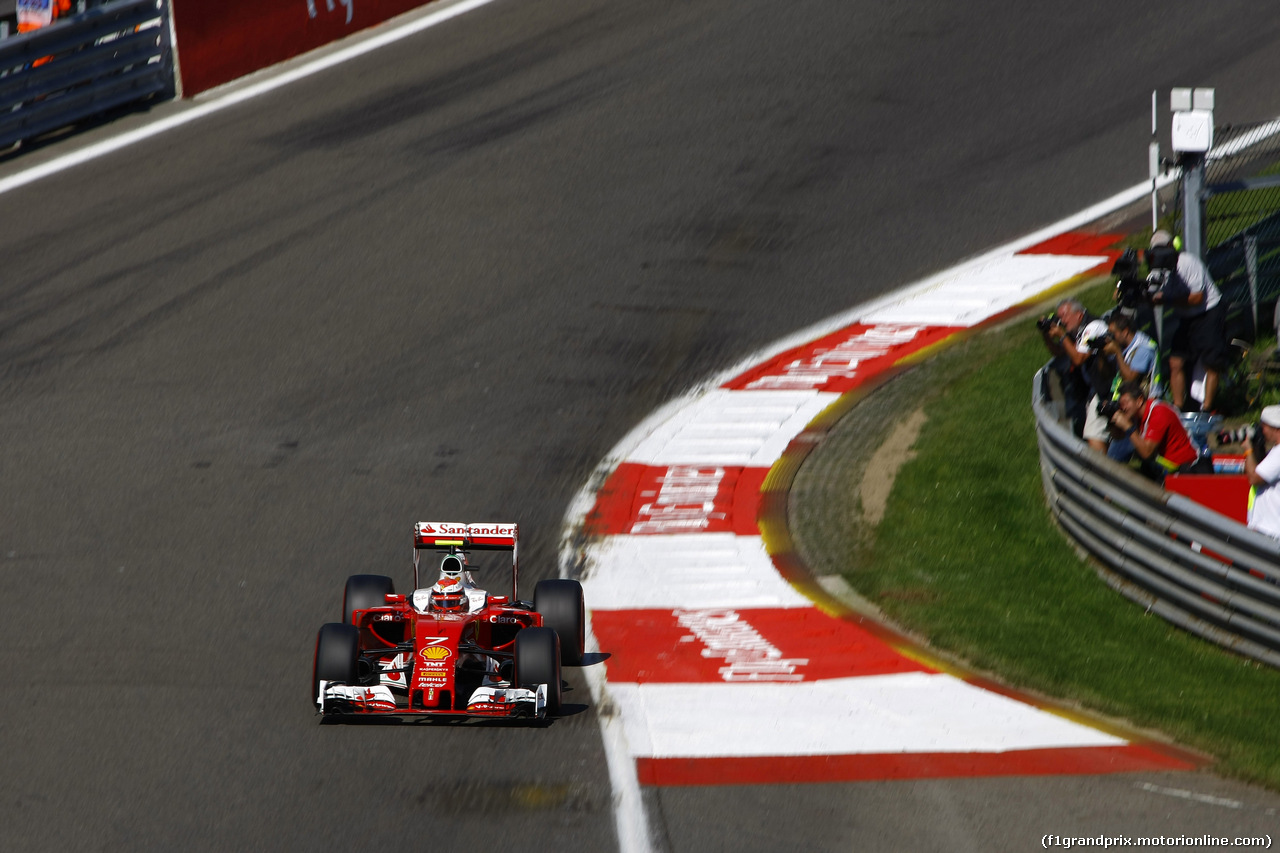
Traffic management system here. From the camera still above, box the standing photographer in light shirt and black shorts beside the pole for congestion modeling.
[1147,231,1230,411]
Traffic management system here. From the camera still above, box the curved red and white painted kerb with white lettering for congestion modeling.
[584,234,1188,785]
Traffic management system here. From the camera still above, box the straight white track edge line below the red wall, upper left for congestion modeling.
[0,0,494,195]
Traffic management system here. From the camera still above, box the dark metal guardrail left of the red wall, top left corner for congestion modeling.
[0,0,174,147]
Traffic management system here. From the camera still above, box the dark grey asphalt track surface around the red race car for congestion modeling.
[0,0,1280,850]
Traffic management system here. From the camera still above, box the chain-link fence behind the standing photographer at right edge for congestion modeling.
[1176,122,1280,337]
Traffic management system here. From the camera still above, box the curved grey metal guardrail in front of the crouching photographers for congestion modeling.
[1032,368,1280,669]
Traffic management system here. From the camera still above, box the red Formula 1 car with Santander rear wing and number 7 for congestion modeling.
[311,521,586,719]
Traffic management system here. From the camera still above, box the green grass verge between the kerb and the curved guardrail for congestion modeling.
[790,277,1280,789]
